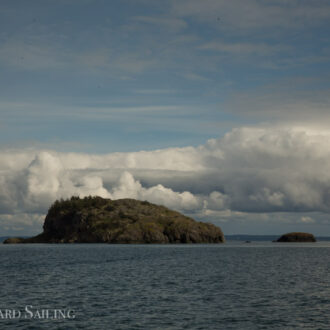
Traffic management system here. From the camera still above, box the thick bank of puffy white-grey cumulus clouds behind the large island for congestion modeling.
[0,127,330,233]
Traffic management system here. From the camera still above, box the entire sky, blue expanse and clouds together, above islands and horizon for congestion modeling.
[0,0,330,236]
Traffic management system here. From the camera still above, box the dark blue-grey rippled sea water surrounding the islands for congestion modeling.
[0,242,330,329]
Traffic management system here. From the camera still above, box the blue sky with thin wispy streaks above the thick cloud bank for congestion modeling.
[0,0,330,153]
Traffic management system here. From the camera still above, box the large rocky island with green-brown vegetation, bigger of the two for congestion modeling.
[5,197,225,243]
